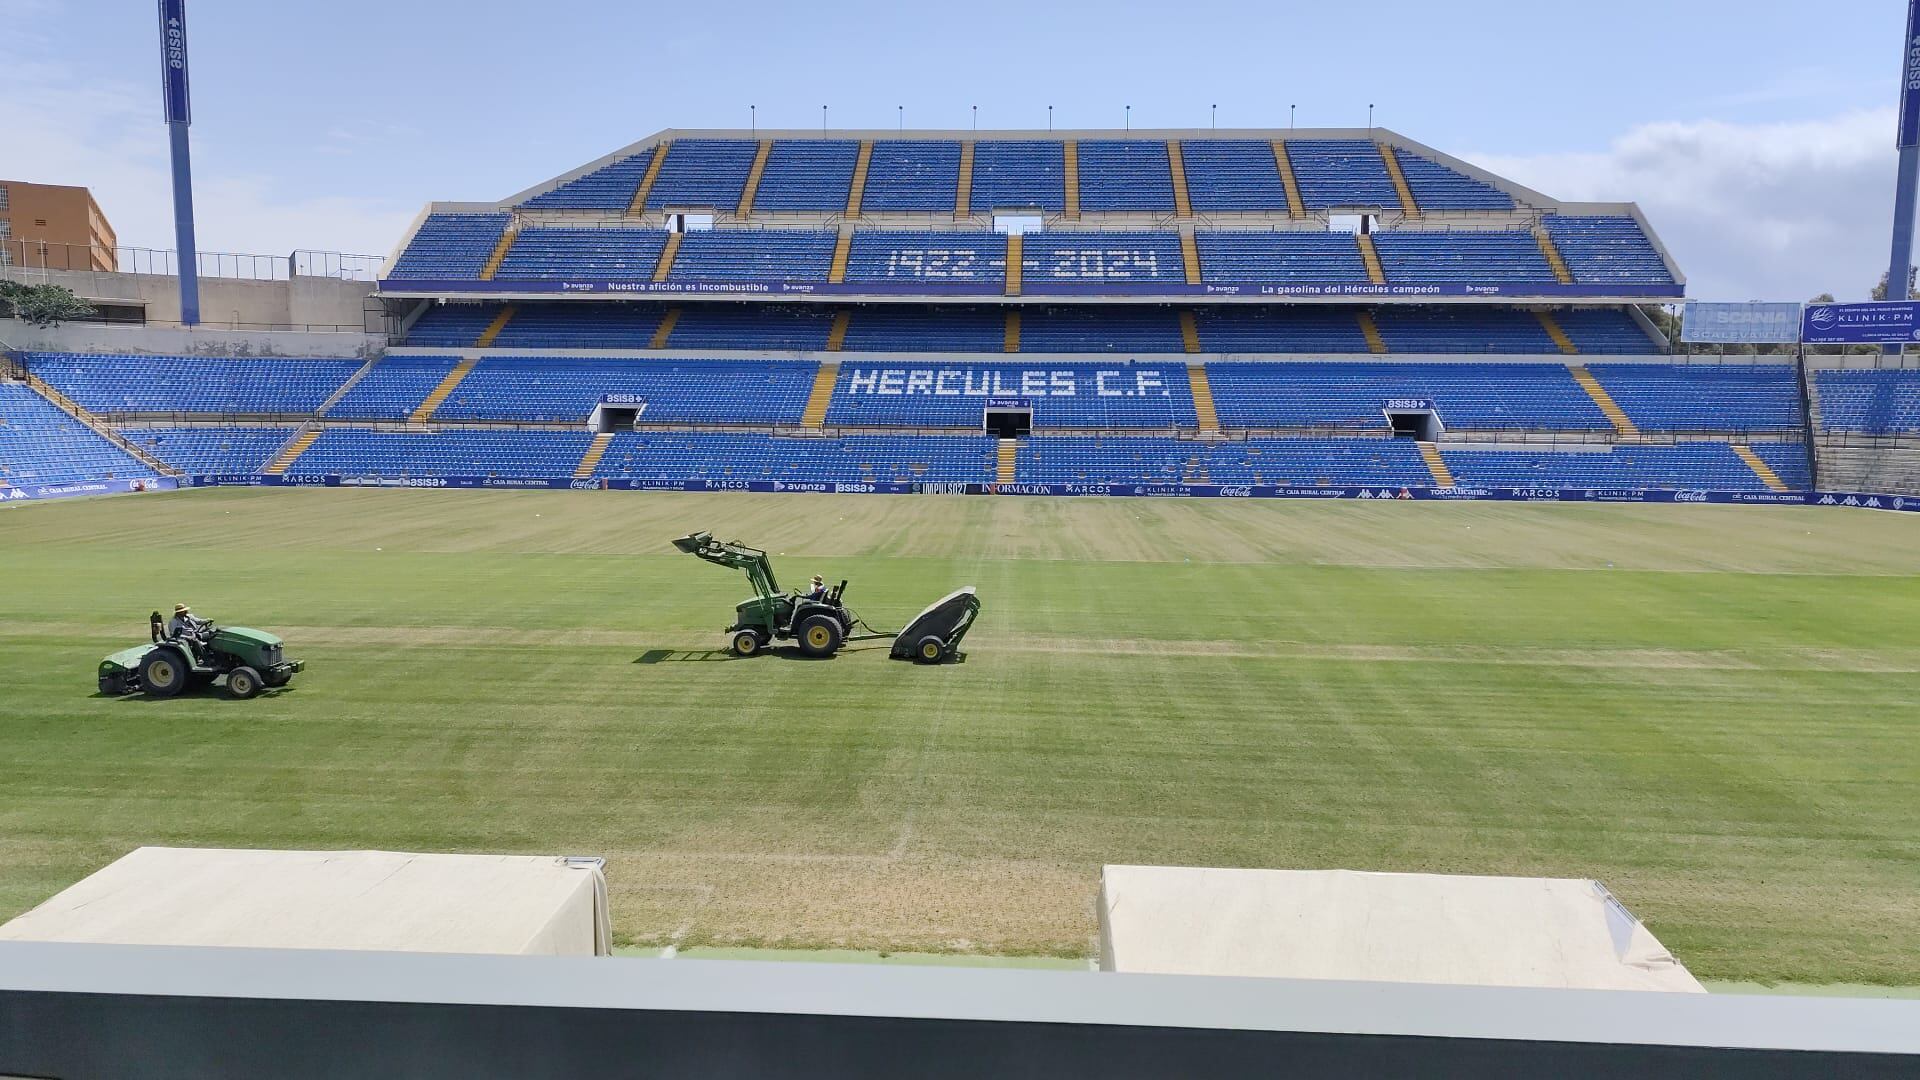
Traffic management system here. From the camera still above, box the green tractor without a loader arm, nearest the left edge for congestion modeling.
[100,611,307,700]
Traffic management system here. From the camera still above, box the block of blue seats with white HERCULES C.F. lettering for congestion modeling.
[828,359,1198,429]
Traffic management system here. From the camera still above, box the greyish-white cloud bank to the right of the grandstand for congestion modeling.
[1463,110,1895,300]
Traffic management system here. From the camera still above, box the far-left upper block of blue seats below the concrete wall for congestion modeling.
[25,352,365,415]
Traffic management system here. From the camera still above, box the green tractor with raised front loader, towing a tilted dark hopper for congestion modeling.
[674,532,979,663]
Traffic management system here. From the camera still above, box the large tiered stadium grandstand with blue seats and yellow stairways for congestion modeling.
[0,129,1827,492]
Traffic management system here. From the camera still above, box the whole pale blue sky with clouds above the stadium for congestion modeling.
[0,0,1905,298]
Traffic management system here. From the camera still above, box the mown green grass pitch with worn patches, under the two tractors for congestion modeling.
[0,490,1920,986]
